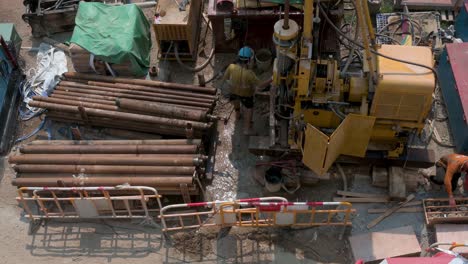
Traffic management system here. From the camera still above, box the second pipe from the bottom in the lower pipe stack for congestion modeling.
[13,164,195,175]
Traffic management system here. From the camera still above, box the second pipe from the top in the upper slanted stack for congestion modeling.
[87,81,216,100]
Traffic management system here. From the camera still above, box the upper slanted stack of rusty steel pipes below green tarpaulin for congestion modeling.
[29,73,216,137]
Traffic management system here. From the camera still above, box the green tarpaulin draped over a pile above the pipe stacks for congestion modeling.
[70,1,151,76]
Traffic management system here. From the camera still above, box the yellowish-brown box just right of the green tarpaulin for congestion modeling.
[153,0,202,59]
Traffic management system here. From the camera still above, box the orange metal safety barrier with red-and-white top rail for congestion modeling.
[159,197,354,231]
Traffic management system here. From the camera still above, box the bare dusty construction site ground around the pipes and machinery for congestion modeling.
[0,0,460,264]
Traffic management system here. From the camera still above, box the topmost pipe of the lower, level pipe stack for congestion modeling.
[29,139,201,145]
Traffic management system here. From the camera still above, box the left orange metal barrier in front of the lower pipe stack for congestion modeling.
[16,185,162,224]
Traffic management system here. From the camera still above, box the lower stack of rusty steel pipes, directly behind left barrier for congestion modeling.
[9,139,208,194]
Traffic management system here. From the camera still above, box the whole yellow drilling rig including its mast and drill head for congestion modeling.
[250,0,436,175]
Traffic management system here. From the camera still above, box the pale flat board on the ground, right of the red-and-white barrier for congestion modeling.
[349,226,421,263]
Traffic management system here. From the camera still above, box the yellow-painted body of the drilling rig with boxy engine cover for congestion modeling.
[273,0,435,175]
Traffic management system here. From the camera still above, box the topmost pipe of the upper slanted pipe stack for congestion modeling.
[63,72,216,94]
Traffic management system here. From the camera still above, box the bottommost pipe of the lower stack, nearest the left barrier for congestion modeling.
[12,175,193,187]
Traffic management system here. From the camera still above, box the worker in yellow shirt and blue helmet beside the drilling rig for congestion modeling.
[223,46,271,135]
